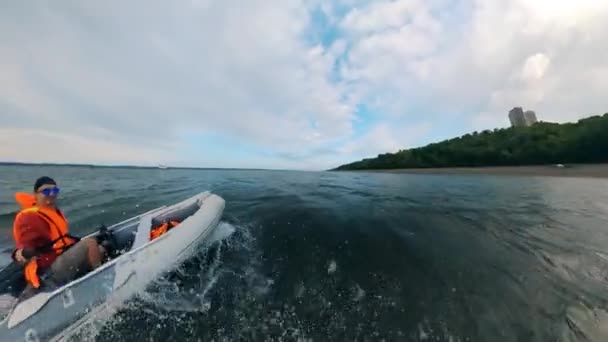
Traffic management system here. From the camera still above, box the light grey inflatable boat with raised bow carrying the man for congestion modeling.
[0,192,225,342]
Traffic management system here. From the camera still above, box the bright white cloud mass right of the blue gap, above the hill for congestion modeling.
[342,0,608,129]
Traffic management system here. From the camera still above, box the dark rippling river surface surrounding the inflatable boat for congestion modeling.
[0,166,608,342]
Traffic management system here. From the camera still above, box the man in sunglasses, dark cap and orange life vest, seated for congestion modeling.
[13,177,104,288]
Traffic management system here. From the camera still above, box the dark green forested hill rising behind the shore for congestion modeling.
[334,113,608,170]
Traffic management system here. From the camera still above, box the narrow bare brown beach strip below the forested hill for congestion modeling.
[344,164,608,178]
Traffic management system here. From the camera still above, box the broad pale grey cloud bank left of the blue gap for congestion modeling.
[0,1,351,169]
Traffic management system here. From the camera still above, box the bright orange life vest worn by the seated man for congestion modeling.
[13,192,76,288]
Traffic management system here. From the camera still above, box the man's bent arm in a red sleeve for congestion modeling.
[13,213,51,263]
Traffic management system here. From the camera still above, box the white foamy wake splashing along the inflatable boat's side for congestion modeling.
[59,222,242,341]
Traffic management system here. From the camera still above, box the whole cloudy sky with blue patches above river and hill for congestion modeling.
[0,0,608,170]
